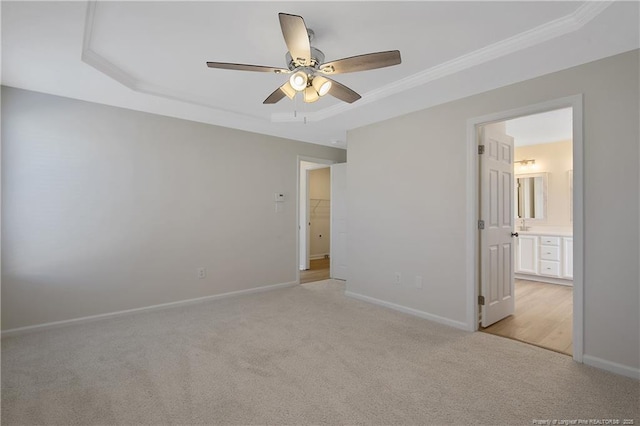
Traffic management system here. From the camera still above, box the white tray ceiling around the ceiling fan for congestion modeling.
[2,1,640,147]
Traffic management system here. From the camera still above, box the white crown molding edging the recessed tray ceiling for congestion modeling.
[81,0,615,123]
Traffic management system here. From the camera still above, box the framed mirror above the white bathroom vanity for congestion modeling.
[514,173,547,220]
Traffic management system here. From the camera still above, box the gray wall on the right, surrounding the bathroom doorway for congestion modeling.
[347,51,640,372]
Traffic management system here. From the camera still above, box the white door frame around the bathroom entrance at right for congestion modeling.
[466,94,584,362]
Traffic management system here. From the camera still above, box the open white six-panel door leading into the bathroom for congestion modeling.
[479,123,515,327]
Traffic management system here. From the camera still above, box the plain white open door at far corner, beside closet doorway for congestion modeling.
[330,163,347,280]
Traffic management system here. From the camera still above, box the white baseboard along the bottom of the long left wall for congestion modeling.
[0,281,298,337]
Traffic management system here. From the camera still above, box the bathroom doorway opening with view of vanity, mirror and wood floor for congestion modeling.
[480,108,573,355]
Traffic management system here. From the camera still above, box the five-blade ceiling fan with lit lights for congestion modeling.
[207,13,401,104]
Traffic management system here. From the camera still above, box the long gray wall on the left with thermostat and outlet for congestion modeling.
[2,87,346,330]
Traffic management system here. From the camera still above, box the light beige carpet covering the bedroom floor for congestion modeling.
[2,280,640,425]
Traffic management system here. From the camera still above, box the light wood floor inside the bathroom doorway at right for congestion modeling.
[481,280,573,355]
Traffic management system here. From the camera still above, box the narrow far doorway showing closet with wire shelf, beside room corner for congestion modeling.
[298,158,333,284]
